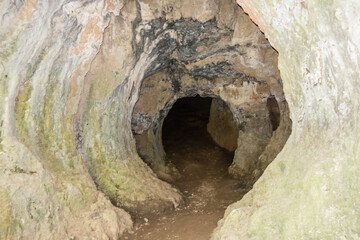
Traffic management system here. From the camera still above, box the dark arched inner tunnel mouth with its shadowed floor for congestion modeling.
[162,95,237,184]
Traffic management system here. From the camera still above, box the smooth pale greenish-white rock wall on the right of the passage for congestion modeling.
[213,0,360,239]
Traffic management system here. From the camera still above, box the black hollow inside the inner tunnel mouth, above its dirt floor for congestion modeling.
[161,95,238,152]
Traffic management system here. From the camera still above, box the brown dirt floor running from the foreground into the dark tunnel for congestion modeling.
[123,123,250,240]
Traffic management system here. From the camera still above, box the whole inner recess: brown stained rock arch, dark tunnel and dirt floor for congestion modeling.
[127,1,292,235]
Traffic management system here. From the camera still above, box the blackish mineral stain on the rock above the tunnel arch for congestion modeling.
[133,15,236,79]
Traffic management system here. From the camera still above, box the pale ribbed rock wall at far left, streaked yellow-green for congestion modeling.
[0,1,132,239]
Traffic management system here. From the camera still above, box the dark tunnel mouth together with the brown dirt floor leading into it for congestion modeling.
[126,95,245,240]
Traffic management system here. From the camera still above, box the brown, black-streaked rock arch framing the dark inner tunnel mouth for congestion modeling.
[131,1,291,180]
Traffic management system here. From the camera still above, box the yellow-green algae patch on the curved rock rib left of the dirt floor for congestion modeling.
[82,96,152,210]
